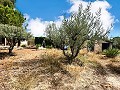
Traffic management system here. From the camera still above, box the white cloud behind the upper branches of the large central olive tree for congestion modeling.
[68,0,114,30]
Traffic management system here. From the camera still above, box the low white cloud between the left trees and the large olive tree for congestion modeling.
[24,14,63,37]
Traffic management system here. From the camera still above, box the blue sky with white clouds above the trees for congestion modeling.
[16,0,120,37]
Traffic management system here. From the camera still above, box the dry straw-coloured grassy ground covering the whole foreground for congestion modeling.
[0,49,120,90]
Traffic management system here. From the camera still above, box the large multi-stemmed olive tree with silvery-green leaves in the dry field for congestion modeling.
[46,4,108,63]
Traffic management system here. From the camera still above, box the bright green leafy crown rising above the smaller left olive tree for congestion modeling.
[0,0,25,27]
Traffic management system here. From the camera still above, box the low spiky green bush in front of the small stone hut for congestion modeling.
[103,49,120,58]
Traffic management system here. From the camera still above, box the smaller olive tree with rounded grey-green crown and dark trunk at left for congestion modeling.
[0,24,27,54]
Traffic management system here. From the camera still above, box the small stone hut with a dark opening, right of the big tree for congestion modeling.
[94,40,112,53]
